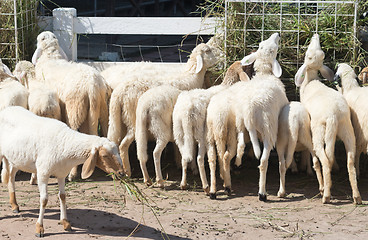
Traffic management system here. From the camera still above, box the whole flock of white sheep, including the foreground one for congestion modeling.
[0,29,368,237]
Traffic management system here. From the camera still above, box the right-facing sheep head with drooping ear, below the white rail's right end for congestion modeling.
[190,43,218,73]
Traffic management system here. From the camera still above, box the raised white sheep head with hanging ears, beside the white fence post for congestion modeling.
[32,31,68,65]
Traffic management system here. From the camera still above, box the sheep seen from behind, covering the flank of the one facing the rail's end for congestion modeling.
[135,85,180,188]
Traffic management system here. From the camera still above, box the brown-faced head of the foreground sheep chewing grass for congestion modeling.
[82,138,124,179]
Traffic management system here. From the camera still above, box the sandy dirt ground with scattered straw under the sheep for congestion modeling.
[0,147,368,240]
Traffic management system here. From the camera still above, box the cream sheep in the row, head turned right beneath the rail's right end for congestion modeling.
[108,43,217,176]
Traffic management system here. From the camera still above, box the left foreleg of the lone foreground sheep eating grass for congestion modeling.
[36,174,48,237]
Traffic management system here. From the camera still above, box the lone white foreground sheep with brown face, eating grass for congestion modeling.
[0,107,123,237]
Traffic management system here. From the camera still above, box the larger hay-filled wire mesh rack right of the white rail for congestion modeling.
[225,0,358,99]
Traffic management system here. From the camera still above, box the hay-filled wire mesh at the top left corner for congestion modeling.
[0,0,38,66]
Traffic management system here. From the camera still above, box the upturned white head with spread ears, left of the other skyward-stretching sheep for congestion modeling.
[241,33,282,77]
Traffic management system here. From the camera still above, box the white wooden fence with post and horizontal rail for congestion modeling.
[39,8,219,68]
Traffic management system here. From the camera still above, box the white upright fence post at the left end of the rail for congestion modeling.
[52,8,77,61]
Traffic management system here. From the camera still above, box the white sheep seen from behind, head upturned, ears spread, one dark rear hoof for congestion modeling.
[216,33,289,201]
